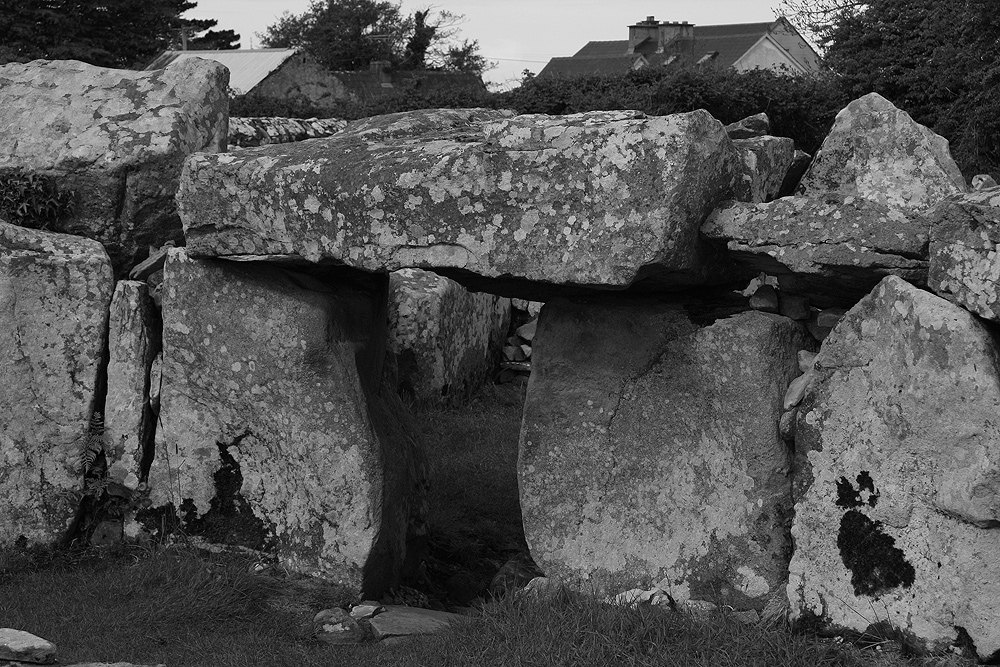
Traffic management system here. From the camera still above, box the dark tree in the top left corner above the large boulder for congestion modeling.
[0,0,239,68]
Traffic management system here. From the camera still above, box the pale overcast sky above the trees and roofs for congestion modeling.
[184,0,779,84]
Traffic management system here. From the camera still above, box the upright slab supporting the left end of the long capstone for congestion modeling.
[148,249,425,597]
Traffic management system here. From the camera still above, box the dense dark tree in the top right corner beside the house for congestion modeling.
[786,0,1000,176]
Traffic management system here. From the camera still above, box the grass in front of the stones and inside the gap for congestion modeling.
[0,380,976,667]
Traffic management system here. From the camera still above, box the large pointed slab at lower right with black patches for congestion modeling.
[788,276,1000,657]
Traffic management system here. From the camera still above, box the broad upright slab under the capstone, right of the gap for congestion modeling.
[518,297,810,609]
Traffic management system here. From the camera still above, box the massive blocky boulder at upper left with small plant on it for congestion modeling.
[0,58,229,276]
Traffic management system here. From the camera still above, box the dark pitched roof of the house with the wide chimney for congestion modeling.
[538,19,812,76]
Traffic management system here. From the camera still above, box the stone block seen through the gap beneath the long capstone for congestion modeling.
[389,269,510,402]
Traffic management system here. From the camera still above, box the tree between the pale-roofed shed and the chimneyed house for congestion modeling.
[259,0,490,74]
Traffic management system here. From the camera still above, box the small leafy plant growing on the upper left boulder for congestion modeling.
[0,169,75,229]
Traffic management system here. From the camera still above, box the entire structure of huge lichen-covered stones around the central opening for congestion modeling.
[0,58,1000,658]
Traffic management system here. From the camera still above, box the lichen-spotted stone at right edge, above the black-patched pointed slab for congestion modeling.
[928,189,1000,320]
